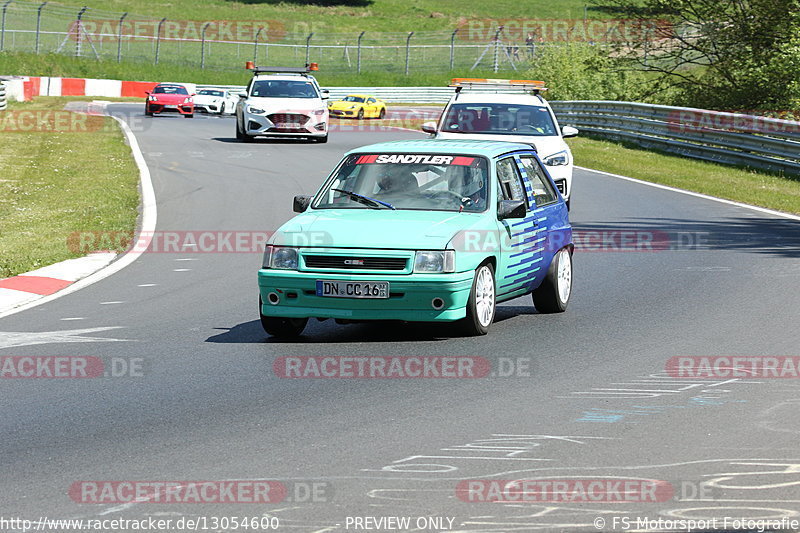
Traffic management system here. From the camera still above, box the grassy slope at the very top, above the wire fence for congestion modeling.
[36,0,607,33]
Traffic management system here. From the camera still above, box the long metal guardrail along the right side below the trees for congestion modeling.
[550,101,800,174]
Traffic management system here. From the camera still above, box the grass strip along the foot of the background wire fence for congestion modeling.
[0,52,504,87]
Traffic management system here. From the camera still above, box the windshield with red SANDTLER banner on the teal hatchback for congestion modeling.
[314,154,488,212]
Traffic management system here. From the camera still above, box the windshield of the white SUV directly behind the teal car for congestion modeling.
[442,103,557,136]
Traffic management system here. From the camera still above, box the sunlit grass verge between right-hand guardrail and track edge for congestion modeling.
[569,137,800,214]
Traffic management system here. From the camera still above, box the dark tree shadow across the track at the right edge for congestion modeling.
[572,217,800,258]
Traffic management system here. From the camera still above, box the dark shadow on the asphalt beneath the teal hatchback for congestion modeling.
[206,305,536,344]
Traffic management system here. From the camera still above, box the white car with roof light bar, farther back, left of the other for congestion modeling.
[236,67,328,143]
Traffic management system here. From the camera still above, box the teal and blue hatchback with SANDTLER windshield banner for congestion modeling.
[258,139,574,337]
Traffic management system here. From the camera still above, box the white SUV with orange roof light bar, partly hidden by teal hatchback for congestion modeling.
[422,78,578,208]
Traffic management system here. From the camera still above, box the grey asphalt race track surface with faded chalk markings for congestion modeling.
[0,105,800,532]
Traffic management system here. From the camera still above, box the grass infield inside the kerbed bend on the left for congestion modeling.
[0,97,139,278]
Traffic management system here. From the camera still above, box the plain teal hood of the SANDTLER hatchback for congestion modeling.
[272,208,485,250]
